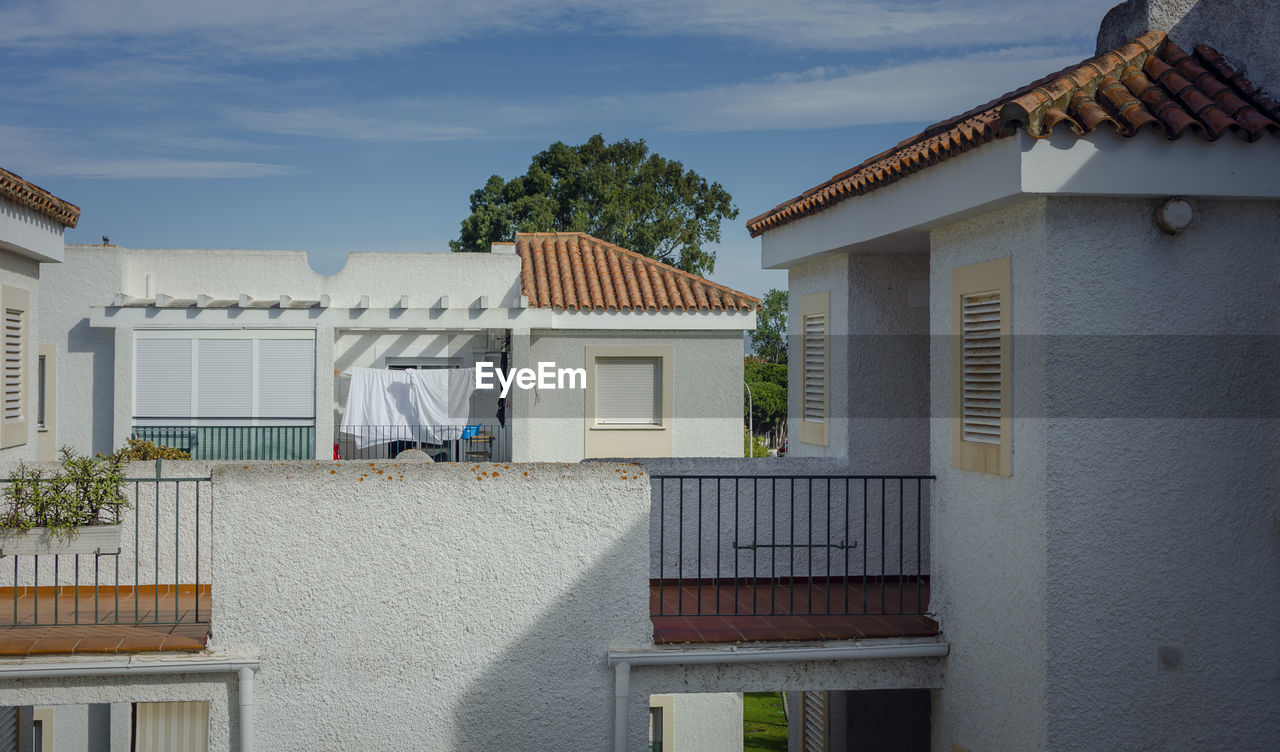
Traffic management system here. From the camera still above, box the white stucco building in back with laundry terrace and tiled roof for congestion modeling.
[41,233,756,462]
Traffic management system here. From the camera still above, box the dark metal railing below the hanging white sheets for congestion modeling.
[337,422,511,462]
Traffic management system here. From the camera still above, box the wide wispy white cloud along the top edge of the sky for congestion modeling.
[0,0,1114,59]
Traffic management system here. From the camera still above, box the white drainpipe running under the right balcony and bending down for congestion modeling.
[609,642,950,752]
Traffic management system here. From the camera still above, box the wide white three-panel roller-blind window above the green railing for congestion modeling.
[133,331,315,423]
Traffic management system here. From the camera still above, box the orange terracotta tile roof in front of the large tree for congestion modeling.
[516,233,760,311]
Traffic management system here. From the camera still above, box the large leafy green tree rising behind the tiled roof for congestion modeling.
[449,134,737,275]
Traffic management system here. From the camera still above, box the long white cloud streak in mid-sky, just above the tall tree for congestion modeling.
[228,47,1085,142]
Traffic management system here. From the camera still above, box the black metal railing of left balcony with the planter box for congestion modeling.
[0,464,212,627]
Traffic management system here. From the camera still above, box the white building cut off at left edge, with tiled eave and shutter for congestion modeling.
[0,169,79,462]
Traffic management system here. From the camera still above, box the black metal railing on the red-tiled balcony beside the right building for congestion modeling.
[650,476,933,616]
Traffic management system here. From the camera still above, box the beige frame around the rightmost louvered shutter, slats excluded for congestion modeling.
[951,256,1014,477]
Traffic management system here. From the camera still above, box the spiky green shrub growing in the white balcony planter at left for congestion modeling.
[0,446,132,538]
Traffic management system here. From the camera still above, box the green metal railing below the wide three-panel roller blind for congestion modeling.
[133,426,316,460]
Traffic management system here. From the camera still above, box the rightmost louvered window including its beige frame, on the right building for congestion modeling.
[951,258,1012,476]
